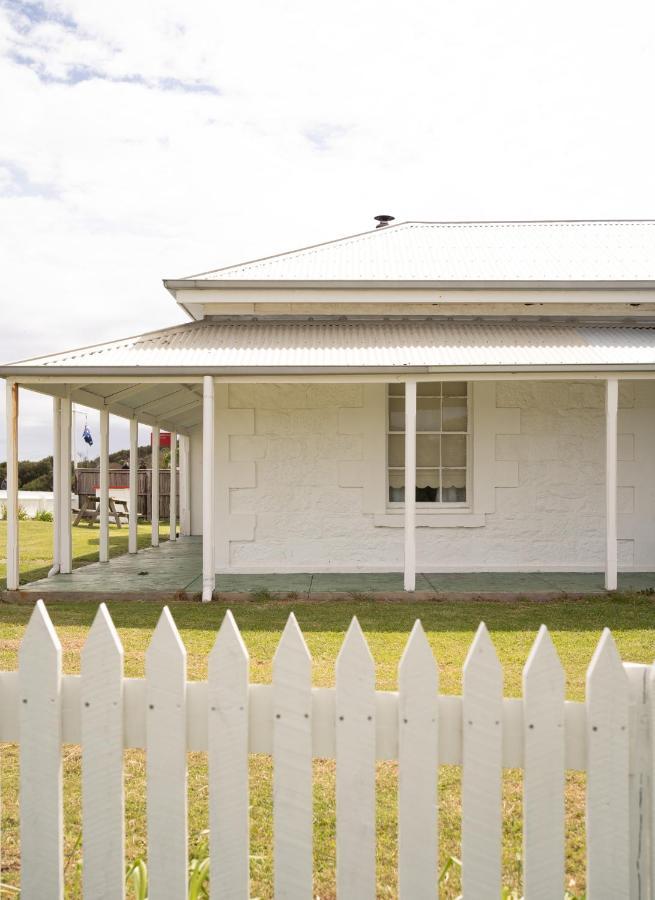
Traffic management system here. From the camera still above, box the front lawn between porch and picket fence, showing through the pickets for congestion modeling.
[0,595,655,898]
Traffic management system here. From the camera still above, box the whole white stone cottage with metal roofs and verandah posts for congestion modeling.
[0,217,655,600]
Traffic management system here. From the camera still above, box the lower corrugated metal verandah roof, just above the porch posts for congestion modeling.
[6,319,655,374]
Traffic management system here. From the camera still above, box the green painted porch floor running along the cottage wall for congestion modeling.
[14,538,655,596]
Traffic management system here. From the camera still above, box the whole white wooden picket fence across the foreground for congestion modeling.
[0,601,655,900]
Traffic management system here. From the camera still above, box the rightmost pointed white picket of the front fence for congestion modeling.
[586,628,630,898]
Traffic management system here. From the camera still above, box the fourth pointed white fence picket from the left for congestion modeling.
[207,610,250,900]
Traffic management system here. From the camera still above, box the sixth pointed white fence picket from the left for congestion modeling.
[336,618,376,900]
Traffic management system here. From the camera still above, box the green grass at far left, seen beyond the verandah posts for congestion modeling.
[0,519,169,590]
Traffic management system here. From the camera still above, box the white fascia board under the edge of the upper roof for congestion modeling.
[174,282,655,306]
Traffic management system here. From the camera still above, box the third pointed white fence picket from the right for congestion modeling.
[462,622,503,897]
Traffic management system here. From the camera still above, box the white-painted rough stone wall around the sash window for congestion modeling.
[191,381,655,571]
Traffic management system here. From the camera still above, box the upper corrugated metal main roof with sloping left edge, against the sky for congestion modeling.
[178,221,655,285]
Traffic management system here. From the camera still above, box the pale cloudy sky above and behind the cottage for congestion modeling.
[0,0,655,459]
